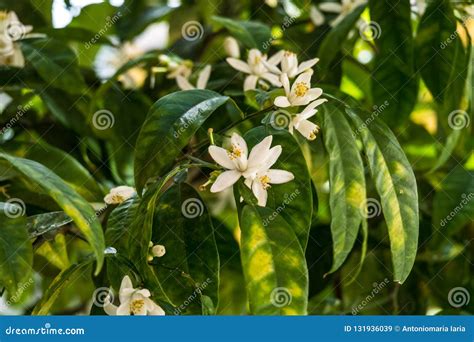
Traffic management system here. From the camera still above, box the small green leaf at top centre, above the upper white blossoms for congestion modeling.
[212,16,272,50]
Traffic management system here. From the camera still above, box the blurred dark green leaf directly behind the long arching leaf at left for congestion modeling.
[0,139,103,202]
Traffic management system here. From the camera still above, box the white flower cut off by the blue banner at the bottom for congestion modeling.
[104,276,165,316]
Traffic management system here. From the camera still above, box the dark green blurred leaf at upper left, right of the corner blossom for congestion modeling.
[21,38,86,94]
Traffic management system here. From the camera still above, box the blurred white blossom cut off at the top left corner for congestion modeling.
[0,11,33,68]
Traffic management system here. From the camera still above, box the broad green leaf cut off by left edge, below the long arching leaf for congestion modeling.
[0,208,33,296]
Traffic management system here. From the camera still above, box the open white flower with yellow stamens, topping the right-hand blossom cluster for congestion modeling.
[274,70,323,108]
